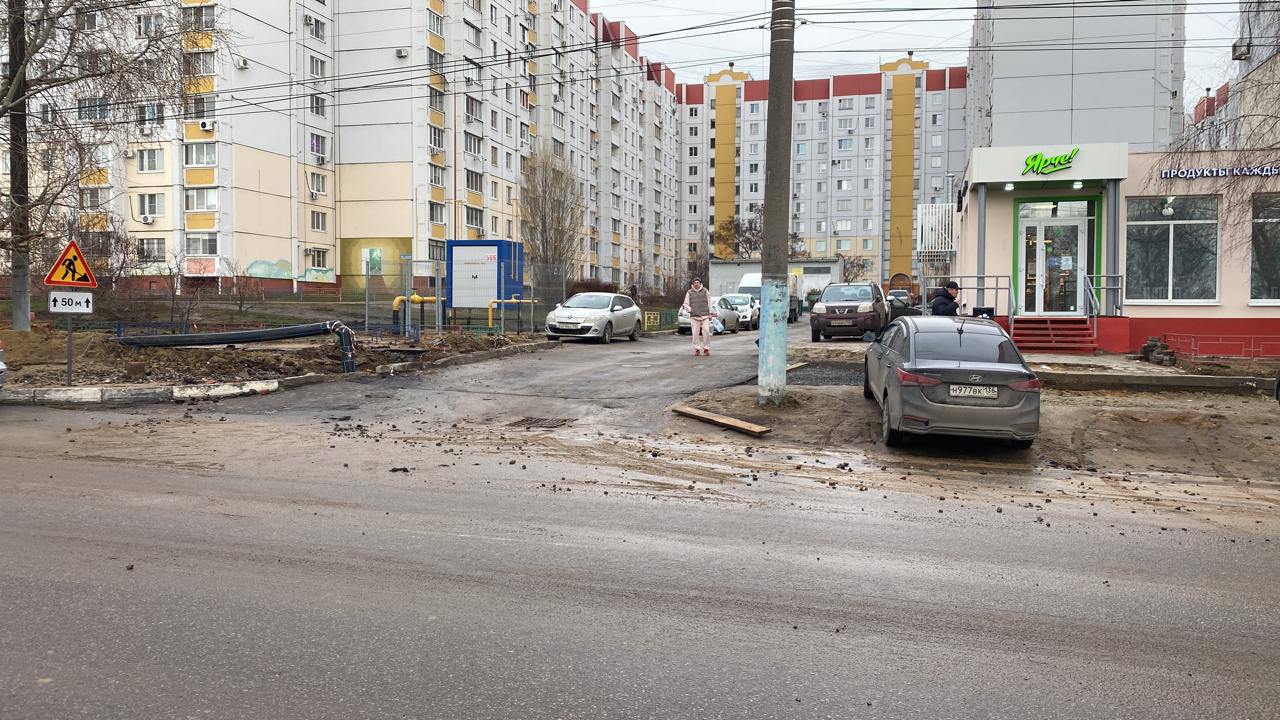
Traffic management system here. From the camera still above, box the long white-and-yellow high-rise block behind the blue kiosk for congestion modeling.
[81,0,682,290]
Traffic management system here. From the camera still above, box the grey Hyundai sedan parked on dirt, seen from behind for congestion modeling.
[863,315,1041,448]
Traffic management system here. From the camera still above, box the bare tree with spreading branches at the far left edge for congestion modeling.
[0,0,221,331]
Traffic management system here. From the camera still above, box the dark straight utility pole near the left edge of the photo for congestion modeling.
[6,0,31,332]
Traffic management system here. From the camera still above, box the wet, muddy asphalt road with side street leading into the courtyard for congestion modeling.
[0,327,1280,720]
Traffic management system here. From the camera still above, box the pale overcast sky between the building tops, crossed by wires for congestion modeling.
[591,0,1238,110]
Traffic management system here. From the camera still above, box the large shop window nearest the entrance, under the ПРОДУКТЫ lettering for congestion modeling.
[1125,197,1217,301]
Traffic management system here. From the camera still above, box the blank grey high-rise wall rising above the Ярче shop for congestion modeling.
[966,0,1187,151]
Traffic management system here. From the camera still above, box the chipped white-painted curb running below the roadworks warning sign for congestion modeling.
[0,373,346,406]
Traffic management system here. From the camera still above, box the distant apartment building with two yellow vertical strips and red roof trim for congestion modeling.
[676,55,968,282]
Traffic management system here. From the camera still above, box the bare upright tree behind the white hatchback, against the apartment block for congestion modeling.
[520,147,586,295]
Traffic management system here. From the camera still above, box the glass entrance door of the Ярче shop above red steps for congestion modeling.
[1021,220,1087,315]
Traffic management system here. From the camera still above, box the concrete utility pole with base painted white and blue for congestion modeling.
[756,0,796,405]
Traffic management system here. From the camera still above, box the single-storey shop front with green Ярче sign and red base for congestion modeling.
[955,143,1280,356]
